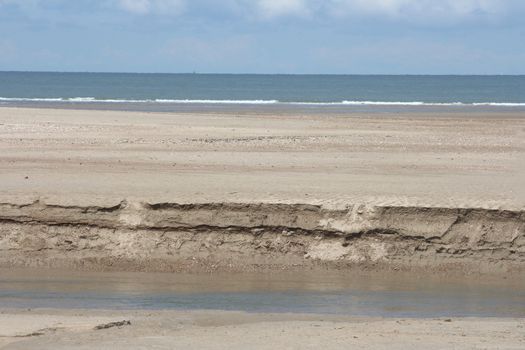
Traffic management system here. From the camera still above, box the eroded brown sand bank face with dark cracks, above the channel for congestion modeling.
[0,202,525,273]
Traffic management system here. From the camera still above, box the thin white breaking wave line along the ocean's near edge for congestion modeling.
[0,97,525,107]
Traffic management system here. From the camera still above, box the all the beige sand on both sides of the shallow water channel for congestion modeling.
[0,108,525,349]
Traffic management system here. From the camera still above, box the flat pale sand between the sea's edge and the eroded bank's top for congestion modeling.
[0,108,525,209]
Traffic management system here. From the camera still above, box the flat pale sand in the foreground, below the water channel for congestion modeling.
[0,310,525,349]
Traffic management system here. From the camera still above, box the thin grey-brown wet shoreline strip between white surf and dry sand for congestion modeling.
[4,100,525,117]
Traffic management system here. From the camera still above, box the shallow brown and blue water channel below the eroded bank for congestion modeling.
[0,269,525,317]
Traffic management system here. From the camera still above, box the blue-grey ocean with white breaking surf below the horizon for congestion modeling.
[0,72,525,110]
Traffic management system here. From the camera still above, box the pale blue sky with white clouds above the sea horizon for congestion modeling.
[0,0,525,74]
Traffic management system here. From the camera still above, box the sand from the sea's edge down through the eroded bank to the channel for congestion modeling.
[0,108,525,272]
